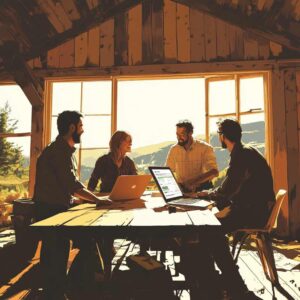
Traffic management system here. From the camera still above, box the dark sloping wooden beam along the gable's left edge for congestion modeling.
[23,0,142,60]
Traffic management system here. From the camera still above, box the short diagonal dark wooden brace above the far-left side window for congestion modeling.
[0,42,43,106]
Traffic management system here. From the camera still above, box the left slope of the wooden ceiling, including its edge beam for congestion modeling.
[0,0,141,67]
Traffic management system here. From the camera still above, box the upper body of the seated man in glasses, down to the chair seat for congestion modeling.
[198,119,275,232]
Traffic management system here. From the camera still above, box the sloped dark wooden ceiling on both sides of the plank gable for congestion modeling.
[0,0,300,71]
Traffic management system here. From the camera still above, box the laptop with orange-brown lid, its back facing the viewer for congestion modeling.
[99,174,151,201]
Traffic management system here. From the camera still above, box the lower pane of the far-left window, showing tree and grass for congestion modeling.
[0,137,30,203]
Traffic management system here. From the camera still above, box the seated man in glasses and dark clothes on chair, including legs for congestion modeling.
[183,119,275,299]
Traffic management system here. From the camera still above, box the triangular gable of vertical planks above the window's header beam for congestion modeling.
[29,0,282,68]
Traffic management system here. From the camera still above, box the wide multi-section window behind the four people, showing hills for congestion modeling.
[51,74,266,189]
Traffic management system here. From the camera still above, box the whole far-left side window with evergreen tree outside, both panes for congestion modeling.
[0,84,31,226]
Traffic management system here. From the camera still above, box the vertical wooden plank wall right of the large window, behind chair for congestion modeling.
[269,68,300,238]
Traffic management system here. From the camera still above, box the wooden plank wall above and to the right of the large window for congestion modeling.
[24,0,300,238]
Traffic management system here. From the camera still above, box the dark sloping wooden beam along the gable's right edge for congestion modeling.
[172,0,300,51]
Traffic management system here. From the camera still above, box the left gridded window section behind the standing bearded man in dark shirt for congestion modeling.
[51,80,112,183]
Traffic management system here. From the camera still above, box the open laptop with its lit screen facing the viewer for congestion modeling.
[149,167,212,209]
